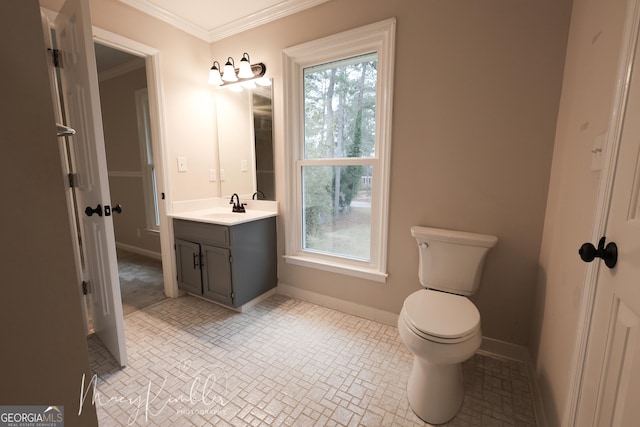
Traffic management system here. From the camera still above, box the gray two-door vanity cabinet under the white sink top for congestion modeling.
[173,217,278,307]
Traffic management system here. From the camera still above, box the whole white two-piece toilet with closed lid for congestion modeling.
[398,226,498,424]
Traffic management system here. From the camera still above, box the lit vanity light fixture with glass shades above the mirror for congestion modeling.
[209,52,271,90]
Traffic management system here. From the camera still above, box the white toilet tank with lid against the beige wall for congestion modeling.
[411,226,498,295]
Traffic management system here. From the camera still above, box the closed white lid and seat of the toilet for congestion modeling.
[402,289,480,344]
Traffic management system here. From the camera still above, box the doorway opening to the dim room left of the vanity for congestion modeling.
[94,43,165,324]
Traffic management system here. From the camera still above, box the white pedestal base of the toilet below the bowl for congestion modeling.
[407,356,464,424]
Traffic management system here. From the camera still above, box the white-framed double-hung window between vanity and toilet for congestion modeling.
[284,19,395,281]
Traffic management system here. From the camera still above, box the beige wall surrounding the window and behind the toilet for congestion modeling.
[211,0,570,345]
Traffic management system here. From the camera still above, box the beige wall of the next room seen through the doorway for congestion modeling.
[100,67,160,254]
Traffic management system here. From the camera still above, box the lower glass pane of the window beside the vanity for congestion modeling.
[302,165,372,261]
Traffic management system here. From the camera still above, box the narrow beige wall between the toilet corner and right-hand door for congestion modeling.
[530,0,626,426]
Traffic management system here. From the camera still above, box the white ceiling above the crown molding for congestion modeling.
[120,0,329,43]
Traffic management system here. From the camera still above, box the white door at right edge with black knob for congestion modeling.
[574,1,640,427]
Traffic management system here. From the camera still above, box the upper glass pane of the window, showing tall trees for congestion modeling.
[304,53,378,159]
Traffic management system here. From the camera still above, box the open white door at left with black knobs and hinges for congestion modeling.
[55,0,127,366]
